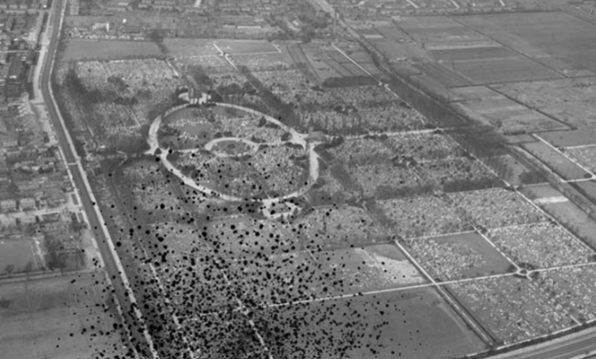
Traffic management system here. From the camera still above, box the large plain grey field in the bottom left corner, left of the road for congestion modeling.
[0,273,132,359]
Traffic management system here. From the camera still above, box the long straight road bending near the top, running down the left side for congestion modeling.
[41,0,155,357]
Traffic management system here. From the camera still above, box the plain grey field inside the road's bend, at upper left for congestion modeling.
[60,40,162,62]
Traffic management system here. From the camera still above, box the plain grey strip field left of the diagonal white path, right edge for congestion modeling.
[522,142,591,180]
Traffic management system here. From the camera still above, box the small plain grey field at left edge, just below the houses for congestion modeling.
[0,240,41,275]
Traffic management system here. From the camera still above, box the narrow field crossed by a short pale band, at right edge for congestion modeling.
[523,185,596,249]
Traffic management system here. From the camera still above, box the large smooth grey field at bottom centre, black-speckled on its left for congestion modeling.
[255,289,483,359]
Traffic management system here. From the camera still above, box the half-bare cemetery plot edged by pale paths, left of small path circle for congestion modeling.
[403,232,511,281]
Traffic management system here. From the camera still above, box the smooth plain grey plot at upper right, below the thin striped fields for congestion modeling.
[454,57,562,84]
